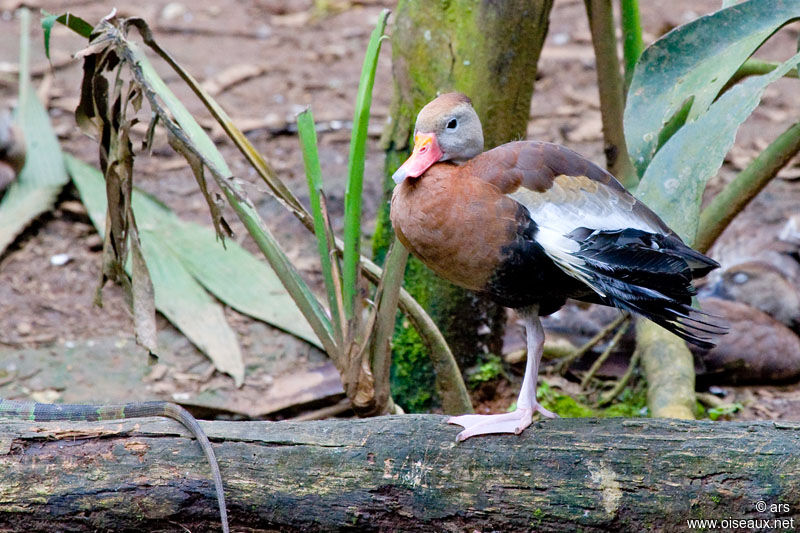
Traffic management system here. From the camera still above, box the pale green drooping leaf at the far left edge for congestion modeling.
[0,9,69,253]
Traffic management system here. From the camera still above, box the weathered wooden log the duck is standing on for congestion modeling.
[0,415,800,532]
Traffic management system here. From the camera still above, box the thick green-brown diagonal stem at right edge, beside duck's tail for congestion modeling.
[694,122,800,252]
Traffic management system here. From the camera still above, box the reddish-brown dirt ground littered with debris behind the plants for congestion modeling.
[0,0,800,419]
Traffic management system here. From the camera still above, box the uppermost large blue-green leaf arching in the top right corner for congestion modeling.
[624,0,800,176]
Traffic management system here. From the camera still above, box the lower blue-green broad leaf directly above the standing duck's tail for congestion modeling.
[635,54,800,244]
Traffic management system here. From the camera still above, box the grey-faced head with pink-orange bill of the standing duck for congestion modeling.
[392,93,483,183]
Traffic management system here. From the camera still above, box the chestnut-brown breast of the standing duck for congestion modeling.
[391,163,517,290]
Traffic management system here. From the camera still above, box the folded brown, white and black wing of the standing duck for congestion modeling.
[467,141,721,345]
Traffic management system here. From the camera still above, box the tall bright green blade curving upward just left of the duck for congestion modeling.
[342,10,389,320]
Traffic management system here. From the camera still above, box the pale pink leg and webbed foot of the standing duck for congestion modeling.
[447,309,558,441]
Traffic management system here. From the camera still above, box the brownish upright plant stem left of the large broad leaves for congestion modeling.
[584,0,638,189]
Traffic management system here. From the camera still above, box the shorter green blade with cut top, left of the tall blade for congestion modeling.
[297,109,341,336]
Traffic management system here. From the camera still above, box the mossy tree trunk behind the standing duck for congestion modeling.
[375,0,552,410]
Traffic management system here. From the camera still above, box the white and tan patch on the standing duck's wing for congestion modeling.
[508,175,659,296]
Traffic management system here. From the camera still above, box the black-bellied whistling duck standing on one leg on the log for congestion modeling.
[391,93,722,440]
